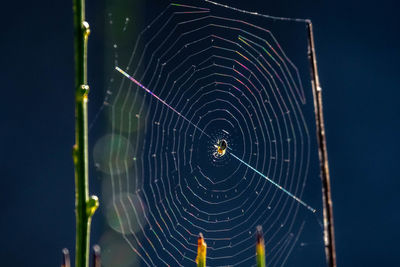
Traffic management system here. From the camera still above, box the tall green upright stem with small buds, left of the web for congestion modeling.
[73,0,98,267]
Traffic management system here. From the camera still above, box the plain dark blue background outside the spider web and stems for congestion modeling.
[0,0,400,266]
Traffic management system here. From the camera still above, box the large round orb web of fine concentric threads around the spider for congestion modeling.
[94,1,324,266]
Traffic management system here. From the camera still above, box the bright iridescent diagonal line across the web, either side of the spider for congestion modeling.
[115,67,316,213]
